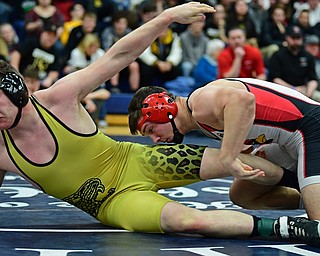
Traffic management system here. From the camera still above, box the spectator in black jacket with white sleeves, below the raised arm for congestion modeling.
[139,28,182,86]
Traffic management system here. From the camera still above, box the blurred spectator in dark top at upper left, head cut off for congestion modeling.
[25,0,64,38]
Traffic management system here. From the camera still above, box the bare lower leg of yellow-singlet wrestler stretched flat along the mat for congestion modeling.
[161,202,273,238]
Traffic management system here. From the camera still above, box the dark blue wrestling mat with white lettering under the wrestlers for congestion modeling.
[0,134,320,256]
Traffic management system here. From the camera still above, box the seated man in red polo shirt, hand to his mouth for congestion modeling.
[218,28,266,80]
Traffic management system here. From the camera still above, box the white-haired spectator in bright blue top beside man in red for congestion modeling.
[193,39,225,87]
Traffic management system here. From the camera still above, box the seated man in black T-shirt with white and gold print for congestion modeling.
[10,23,61,88]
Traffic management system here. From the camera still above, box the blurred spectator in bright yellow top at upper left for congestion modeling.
[60,3,85,45]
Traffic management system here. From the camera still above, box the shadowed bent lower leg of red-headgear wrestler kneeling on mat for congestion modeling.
[229,179,300,210]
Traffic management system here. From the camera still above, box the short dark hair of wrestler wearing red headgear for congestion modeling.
[128,86,176,134]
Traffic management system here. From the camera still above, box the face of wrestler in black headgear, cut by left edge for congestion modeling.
[0,90,18,130]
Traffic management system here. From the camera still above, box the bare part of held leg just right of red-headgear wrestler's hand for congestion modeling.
[238,154,283,185]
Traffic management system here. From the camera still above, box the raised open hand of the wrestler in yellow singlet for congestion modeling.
[165,2,216,24]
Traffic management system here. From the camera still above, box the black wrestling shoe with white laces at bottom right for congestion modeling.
[273,216,320,247]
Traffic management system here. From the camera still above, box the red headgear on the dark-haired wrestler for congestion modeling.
[137,92,178,130]
